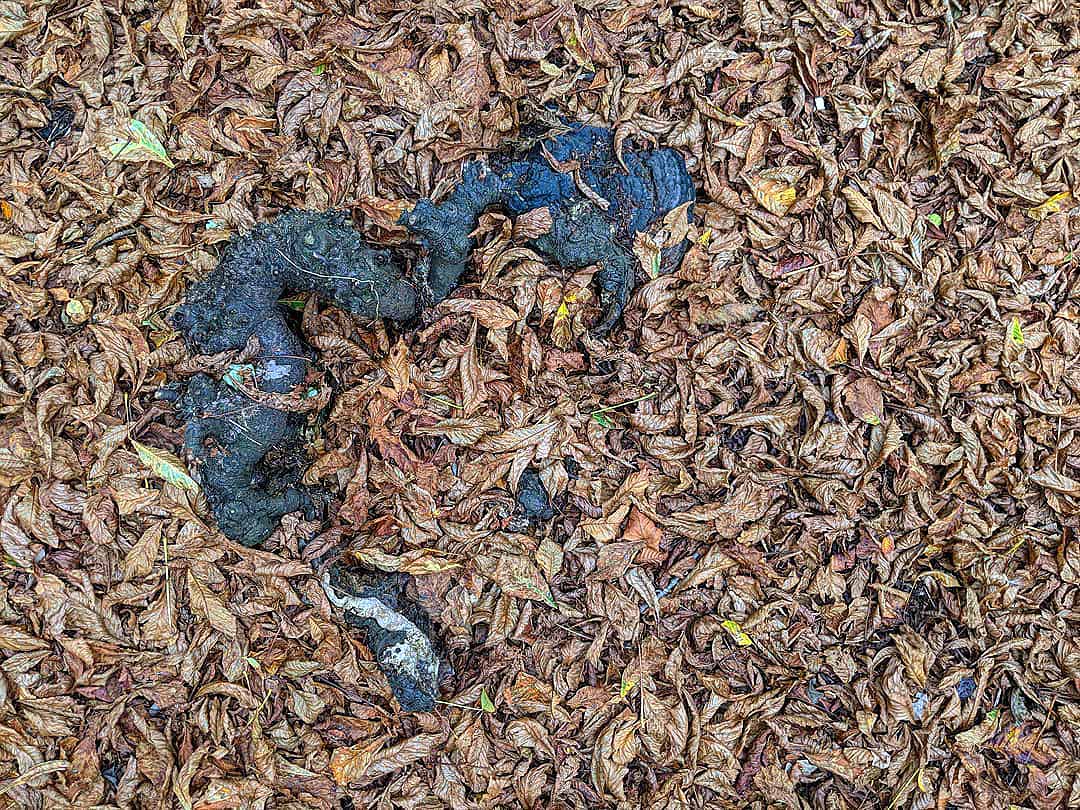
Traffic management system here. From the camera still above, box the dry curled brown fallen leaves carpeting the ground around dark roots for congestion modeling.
[0,0,1080,810]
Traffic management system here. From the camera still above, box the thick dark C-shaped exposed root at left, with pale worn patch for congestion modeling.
[170,211,417,545]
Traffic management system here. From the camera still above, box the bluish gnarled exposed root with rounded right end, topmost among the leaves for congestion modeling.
[401,119,694,336]
